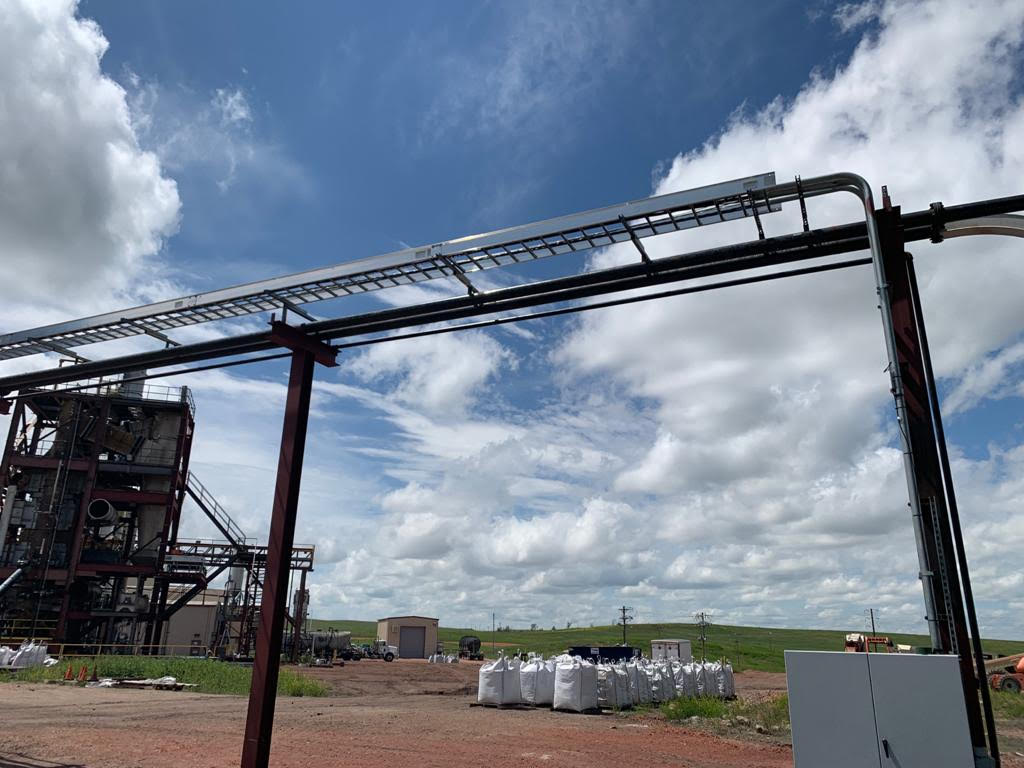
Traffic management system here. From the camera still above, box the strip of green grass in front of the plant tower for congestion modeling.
[0,655,328,696]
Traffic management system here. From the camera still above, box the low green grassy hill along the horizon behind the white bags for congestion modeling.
[310,618,1024,672]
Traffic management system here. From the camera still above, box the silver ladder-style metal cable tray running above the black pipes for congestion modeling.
[0,173,779,359]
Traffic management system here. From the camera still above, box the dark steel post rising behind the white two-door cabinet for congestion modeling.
[877,207,985,754]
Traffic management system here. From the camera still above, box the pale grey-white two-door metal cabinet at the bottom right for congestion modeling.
[785,650,974,768]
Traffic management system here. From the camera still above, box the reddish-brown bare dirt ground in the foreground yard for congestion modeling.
[0,660,793,768]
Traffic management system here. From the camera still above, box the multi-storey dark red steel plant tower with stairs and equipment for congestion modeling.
[0,377,313,657]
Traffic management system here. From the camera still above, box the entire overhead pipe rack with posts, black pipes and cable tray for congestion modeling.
[0,173,1024,767]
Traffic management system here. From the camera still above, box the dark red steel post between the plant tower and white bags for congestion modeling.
[242,349,314,768]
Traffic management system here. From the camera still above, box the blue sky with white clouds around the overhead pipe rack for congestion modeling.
[6,0,1024,637]
